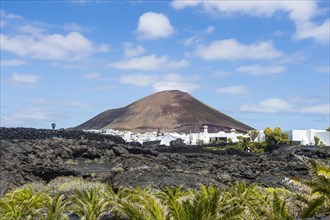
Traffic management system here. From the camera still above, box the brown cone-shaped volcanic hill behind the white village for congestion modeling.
[76,90,253,133]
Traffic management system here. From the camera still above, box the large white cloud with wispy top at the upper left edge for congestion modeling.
[0,10,109,61]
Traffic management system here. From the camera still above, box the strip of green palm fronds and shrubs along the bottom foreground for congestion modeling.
[0,160,330,220]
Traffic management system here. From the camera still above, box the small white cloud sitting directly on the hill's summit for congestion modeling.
[153,81,200,92]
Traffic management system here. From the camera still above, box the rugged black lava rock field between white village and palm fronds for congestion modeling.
[0,128,330,196]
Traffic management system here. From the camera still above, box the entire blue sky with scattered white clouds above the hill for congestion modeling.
[0,0,330,130]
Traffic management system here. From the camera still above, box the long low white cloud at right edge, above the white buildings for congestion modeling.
[240,97,330,115]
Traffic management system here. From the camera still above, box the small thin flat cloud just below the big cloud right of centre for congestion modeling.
[236,65,286,75]
